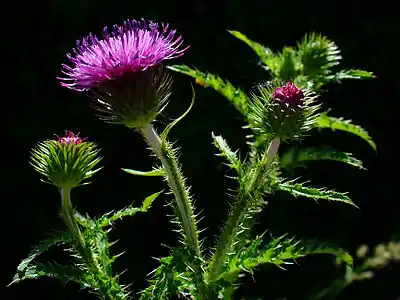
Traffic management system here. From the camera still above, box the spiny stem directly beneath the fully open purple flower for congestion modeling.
[142,123,200,254]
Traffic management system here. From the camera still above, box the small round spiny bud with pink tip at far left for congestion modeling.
[30,131,101,188]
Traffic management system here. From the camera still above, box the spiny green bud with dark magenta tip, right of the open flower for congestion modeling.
[249,81,320,141]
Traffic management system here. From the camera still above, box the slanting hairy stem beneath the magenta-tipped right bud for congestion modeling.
[207,138,280,282]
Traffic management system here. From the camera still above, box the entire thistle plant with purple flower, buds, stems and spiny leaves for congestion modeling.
[13,20,386,299]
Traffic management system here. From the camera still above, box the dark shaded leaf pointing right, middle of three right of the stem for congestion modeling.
[280,147,365,169]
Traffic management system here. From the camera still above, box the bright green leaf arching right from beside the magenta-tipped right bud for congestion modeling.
[316,113,376,151]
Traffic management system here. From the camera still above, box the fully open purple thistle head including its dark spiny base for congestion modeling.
[58,20,188,127]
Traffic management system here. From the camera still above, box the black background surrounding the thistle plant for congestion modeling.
[1,0,400,300]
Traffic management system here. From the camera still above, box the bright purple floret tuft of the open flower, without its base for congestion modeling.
[58,20,189,91]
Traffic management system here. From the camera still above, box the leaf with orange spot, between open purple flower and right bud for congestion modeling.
[168,65,249,116]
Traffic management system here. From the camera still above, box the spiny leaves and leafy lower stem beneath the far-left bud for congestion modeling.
[11,192,161,299]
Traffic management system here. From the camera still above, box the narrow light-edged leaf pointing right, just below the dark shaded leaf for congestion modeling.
[277,181,357,207]
